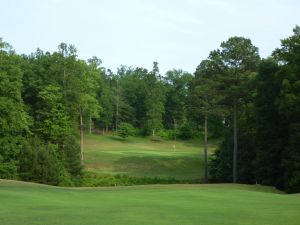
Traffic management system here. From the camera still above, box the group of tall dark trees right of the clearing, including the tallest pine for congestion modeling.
[204,26,300,192]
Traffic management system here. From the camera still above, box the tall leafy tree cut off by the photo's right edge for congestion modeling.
[274,26,300,192]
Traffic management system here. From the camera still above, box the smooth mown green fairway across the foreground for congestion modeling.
[0,180,300,225]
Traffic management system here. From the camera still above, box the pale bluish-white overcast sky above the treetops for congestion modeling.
[0,0,300,74]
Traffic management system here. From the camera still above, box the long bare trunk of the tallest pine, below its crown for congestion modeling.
[232,98,238,183]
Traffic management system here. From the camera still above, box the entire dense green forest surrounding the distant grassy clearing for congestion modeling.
[0,26,300,192]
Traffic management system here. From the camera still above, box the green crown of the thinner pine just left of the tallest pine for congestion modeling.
[189,58,228,138]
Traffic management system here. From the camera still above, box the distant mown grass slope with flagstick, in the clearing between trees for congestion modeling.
[84,135,215,179]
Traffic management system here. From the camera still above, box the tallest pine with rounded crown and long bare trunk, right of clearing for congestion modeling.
[216,37,260,183]
